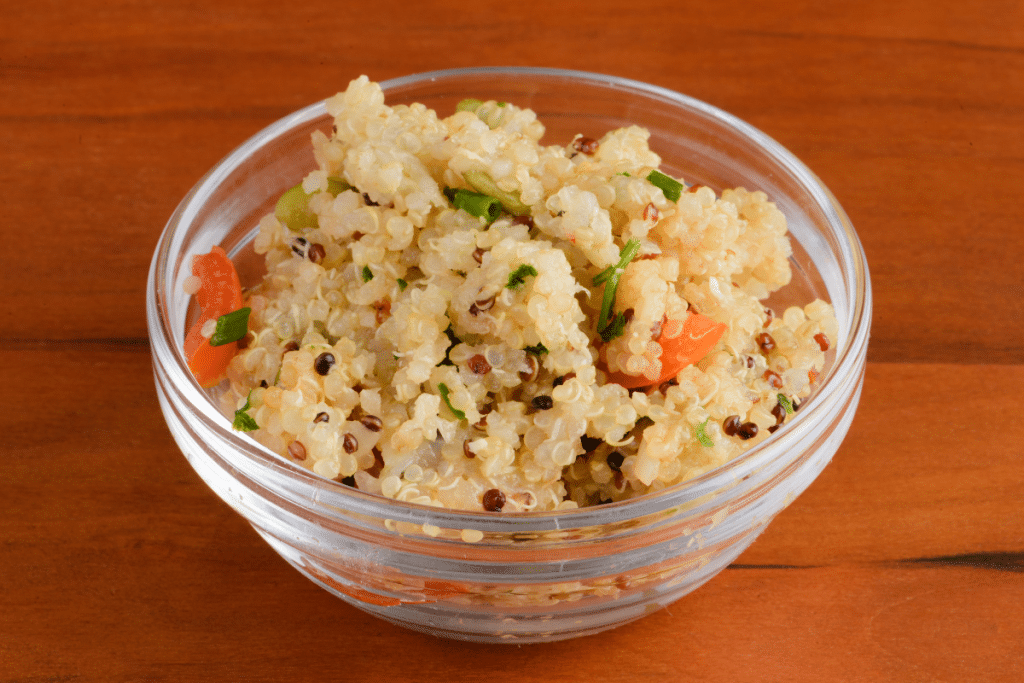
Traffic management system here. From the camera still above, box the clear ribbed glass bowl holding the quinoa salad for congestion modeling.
[146,69,871,642]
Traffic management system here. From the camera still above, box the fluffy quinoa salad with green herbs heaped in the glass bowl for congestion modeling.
[193,76,839,513]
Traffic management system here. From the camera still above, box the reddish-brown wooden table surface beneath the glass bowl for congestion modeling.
[0,0,1024,683]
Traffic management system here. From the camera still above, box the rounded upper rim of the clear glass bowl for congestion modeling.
[146,67,872,531]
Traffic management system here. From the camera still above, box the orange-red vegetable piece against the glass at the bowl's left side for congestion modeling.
[183,247,242,389]
